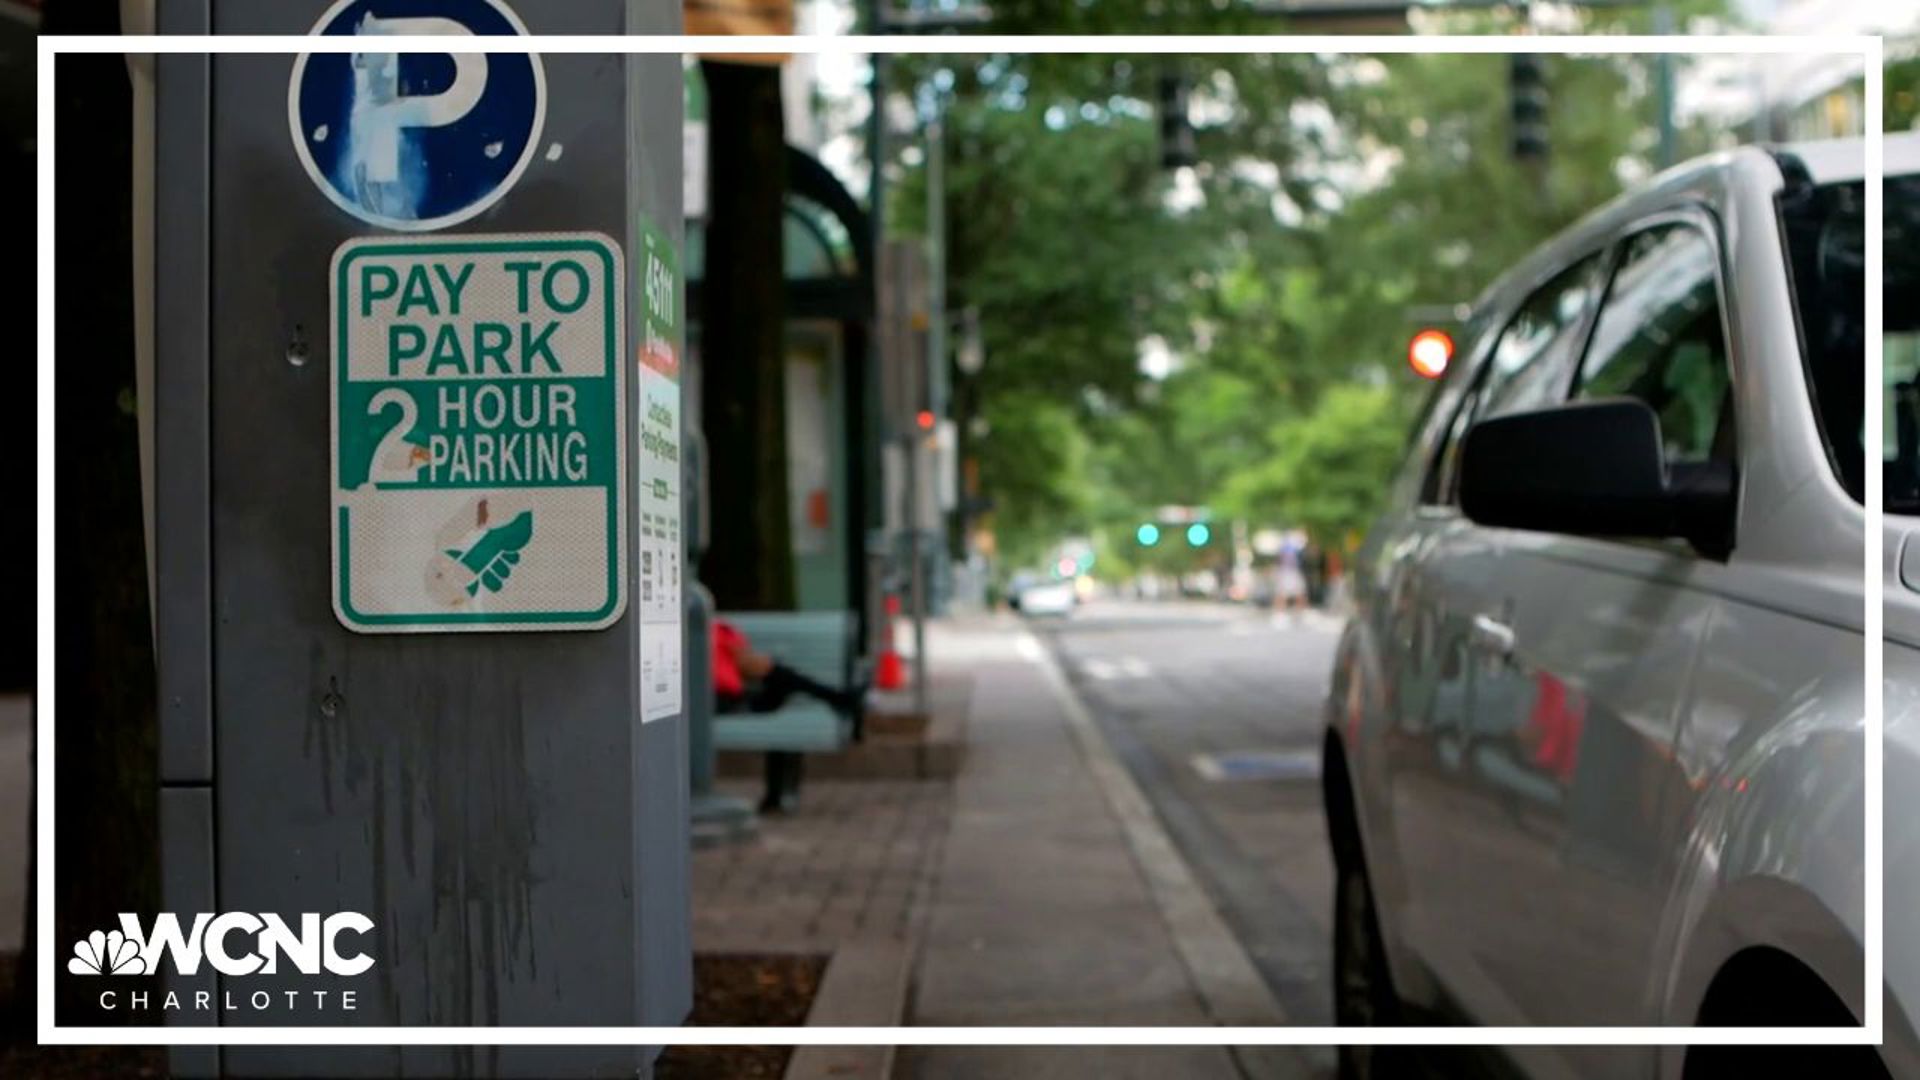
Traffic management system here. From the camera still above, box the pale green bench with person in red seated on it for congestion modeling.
[712,611,862,811]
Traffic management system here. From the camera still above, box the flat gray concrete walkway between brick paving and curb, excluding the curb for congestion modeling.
[912,630,1208,1024]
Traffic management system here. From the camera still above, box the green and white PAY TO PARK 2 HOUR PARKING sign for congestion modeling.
[332,233,626,632]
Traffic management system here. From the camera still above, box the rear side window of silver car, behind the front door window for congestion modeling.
[1421,254,1605,503]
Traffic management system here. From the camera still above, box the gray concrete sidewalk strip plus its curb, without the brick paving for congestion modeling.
[895,617,1306,1080]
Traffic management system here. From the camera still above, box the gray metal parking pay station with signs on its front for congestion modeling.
[146,0,691,1076]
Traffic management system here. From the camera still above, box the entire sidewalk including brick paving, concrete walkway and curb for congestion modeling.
[693,615,1323,1080]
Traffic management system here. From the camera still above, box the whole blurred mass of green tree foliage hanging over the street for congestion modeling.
[889,21,1743,573]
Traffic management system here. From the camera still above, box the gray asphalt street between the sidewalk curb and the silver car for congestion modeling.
[1031,600,1338,1024]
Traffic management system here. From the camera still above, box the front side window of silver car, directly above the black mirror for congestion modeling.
[1574,225,1734,465]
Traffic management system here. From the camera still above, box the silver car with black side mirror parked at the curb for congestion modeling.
[1325,135,1920,1078]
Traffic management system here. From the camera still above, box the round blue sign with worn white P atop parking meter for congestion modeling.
[286,0,547,233]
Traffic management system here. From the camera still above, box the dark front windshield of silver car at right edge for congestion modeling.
[1782,167,1920,513]
